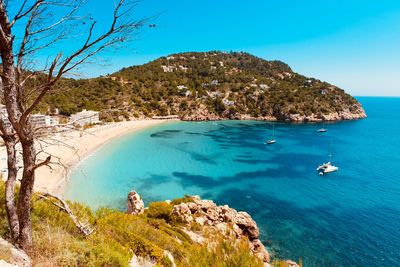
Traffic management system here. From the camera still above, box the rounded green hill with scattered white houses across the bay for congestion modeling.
[42,52,366,121]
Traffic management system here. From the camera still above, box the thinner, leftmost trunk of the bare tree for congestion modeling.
[3,136,19,241]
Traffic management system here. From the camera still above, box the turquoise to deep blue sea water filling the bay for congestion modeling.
[65,98,400,266]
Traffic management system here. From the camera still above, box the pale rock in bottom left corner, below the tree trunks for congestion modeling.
[0,237,32,267]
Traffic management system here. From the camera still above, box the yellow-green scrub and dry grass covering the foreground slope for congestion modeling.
[0,184,268,266]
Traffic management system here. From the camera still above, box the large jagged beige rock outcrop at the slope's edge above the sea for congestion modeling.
[172,196,270,263]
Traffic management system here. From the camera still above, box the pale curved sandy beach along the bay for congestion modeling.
[0,120,165,193]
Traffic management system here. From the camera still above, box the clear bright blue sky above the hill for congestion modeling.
[9,0,400,96]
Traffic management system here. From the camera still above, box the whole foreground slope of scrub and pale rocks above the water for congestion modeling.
[0,191,299,267]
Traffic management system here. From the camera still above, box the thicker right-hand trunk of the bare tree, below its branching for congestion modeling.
[17,138,36,251]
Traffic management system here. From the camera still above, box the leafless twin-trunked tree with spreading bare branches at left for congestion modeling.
[0,0,147,250]
